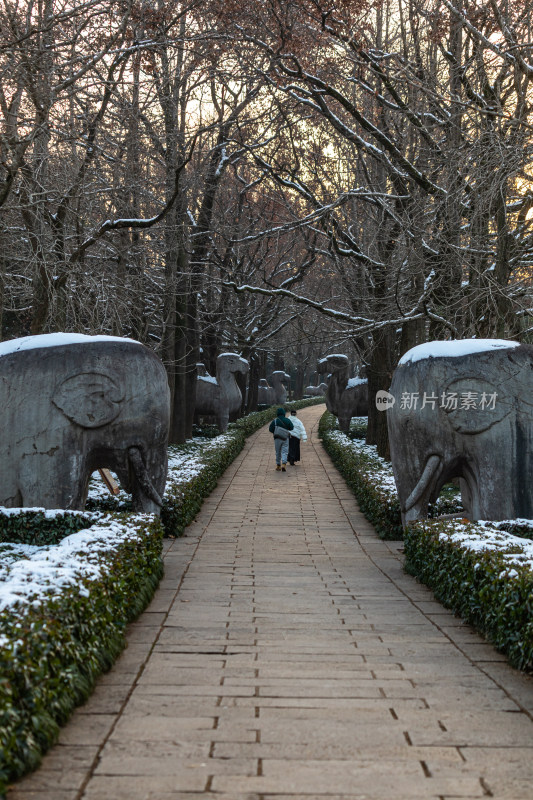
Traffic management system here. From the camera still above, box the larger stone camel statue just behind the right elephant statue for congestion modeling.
[317,353,368,433]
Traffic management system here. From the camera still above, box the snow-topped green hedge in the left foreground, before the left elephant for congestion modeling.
[0,512,163,796]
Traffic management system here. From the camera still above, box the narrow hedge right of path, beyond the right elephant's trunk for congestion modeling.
[318,411,403,539]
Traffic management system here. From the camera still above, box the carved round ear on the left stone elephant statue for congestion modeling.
[52,372,124,428]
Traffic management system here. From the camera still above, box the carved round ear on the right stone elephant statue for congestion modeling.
[440,377,513,434]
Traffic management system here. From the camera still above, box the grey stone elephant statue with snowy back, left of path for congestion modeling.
[0,333,170,513]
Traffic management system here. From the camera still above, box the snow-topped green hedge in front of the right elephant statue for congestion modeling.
[404,520,533,671]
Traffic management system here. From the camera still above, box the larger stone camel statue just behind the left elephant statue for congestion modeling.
[195,353,249,432]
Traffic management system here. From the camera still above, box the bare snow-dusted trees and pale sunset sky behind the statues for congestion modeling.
[0,0,533,453]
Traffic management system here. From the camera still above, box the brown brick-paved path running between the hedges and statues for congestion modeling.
[8,407,533,800]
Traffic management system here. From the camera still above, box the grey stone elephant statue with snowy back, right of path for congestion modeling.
[387,339,533,525]
